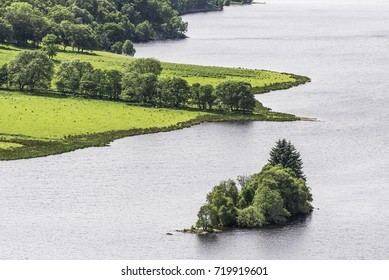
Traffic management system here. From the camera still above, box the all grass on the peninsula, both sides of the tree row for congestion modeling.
[0,46,309,160]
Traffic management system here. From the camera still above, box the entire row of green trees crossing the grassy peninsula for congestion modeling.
[0,51,256,113]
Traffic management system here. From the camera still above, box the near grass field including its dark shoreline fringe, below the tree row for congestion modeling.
[0,91,298,160]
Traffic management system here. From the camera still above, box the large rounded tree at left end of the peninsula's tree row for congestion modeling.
[7,51,54,91]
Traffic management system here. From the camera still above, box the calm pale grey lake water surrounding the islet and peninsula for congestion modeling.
[0,0,389,259]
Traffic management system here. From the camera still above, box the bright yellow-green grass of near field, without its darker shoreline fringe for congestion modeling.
[0,91,206,139]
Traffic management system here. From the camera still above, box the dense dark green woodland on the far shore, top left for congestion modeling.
[0,0,223,52]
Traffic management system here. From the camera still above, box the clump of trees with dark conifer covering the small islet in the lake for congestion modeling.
[196,139,312,231]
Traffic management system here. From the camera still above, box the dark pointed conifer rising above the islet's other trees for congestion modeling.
[269,139,305,179]
